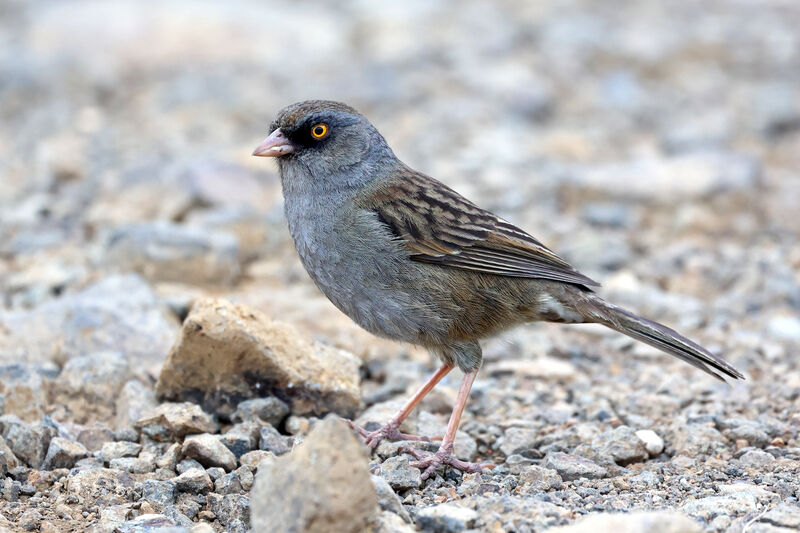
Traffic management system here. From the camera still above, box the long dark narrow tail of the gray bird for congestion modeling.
[584,294,744,381]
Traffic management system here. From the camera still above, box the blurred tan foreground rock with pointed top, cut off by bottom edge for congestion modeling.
[250,415,378,533]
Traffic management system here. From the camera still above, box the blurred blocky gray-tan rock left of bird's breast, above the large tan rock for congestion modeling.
[107,222,240,285]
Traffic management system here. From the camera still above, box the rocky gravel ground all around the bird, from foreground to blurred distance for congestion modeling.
[0,0,800,533]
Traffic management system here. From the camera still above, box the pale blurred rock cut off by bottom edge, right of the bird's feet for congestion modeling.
[549,511,703,533]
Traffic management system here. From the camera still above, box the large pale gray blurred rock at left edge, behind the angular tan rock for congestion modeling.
[0,275,175,366]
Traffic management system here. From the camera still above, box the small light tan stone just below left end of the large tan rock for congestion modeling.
[134,402,219,441]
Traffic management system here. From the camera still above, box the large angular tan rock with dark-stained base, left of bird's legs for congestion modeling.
[156,299,360,416]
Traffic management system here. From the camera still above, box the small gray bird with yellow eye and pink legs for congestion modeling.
[253,100,743,479]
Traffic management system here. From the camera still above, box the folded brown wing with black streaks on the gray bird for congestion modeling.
[363,169,599,286]
